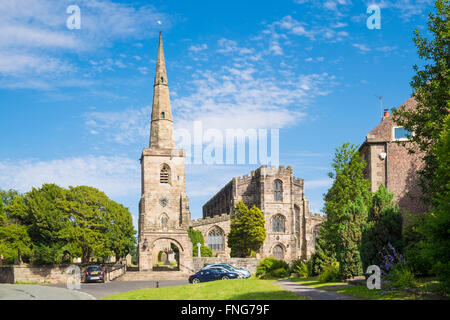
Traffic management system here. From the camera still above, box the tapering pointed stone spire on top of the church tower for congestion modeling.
[150,32,175,149]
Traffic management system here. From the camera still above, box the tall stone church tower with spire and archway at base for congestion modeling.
[138,32,192,272]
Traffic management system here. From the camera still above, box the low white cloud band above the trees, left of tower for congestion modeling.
[0,156,140,197]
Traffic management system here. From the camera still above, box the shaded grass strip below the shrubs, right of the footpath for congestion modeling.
[291,277,445,300]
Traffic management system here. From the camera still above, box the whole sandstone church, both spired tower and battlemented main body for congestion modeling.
[138,33,323,272]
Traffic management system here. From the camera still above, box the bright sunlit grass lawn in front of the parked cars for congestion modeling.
[103,278,306,300]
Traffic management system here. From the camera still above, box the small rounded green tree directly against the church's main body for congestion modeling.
[228,201,266,257]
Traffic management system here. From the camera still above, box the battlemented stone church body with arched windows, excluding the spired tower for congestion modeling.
[191,166,323,261]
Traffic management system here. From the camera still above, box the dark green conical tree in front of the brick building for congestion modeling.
[361,185,403,270]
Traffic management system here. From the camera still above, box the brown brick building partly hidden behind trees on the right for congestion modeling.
[359,97,427,213]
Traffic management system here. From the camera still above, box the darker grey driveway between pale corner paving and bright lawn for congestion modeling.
[46,280,189,299]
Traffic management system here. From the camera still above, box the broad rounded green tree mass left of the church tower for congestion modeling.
[0,184,136,264]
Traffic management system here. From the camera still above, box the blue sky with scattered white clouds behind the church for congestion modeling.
[0,0,432,230]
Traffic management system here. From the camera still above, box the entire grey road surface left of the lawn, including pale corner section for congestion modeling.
[0,280,188,300]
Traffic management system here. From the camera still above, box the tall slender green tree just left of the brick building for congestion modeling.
[321,143,371,277]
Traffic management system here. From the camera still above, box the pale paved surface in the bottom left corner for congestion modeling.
[0,284,95,300]
